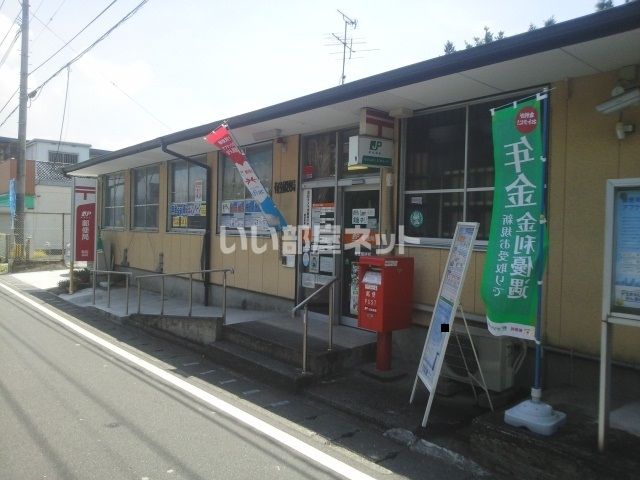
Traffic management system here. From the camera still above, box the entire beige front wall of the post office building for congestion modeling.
[96,73,640,363]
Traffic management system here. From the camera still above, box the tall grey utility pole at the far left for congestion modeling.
[13,0,29,260]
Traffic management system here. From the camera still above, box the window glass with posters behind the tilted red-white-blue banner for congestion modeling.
[218,142,273,234]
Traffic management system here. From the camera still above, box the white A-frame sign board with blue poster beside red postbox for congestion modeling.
[409,222,479,427]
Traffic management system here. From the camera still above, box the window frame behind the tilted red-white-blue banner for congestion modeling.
[216,140,275,237]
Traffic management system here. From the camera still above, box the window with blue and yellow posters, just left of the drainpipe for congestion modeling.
[167,156,207,232]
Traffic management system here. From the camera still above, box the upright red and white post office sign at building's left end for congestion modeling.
[73,178,96,262]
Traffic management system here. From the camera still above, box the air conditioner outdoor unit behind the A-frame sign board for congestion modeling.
[440,324,526,392]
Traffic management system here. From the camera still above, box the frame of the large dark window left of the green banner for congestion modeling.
[398,86,543,251]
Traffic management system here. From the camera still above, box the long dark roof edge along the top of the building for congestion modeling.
[64,2,640,173]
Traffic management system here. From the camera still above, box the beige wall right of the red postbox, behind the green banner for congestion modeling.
[407,73,640,363]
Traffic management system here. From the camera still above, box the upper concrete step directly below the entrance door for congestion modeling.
[222,321,375,377]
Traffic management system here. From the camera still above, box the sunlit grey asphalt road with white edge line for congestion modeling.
[0,287,384,480]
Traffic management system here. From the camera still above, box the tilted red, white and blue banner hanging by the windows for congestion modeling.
[204,125,287,229]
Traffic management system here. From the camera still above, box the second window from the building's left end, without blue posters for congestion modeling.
[131,165,160,230]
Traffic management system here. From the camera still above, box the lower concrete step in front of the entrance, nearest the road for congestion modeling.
[205,340,314,391]
